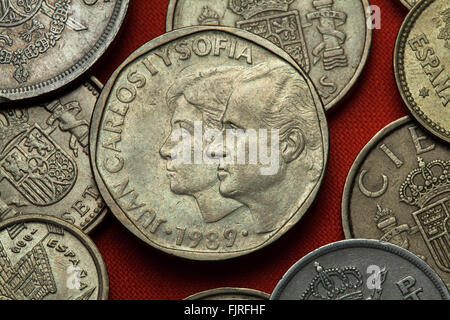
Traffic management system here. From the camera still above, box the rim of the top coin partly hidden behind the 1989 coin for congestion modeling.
[166,0,373,111]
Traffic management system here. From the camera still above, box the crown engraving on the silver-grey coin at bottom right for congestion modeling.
[301,262,363,300]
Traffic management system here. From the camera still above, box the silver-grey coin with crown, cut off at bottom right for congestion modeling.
[270,239,450,300]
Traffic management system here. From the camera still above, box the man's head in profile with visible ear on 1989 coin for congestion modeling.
[215,63,325,233]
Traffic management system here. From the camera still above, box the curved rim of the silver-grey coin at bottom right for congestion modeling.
[270,239,450,300]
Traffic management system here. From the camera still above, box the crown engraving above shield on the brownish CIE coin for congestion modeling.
[400,157,450,208]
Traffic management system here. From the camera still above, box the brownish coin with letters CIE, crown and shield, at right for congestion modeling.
[342,117,450,287]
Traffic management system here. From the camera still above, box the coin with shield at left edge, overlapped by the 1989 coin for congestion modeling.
[0,78,106,232]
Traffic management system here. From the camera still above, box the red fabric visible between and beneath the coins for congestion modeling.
[92,0,407,300]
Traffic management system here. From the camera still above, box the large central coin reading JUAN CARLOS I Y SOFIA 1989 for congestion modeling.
[90,27,328,260]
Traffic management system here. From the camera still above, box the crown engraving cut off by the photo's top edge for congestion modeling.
[228,0,294,19]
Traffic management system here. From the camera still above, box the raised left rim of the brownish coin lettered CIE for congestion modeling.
[341,116,413,239]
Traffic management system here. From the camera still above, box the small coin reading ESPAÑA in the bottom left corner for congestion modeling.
[0,215,109,300]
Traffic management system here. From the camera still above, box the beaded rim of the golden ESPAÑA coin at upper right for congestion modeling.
[394,0,450,143]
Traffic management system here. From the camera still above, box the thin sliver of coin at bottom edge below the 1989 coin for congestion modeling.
[185,288,270,300]
